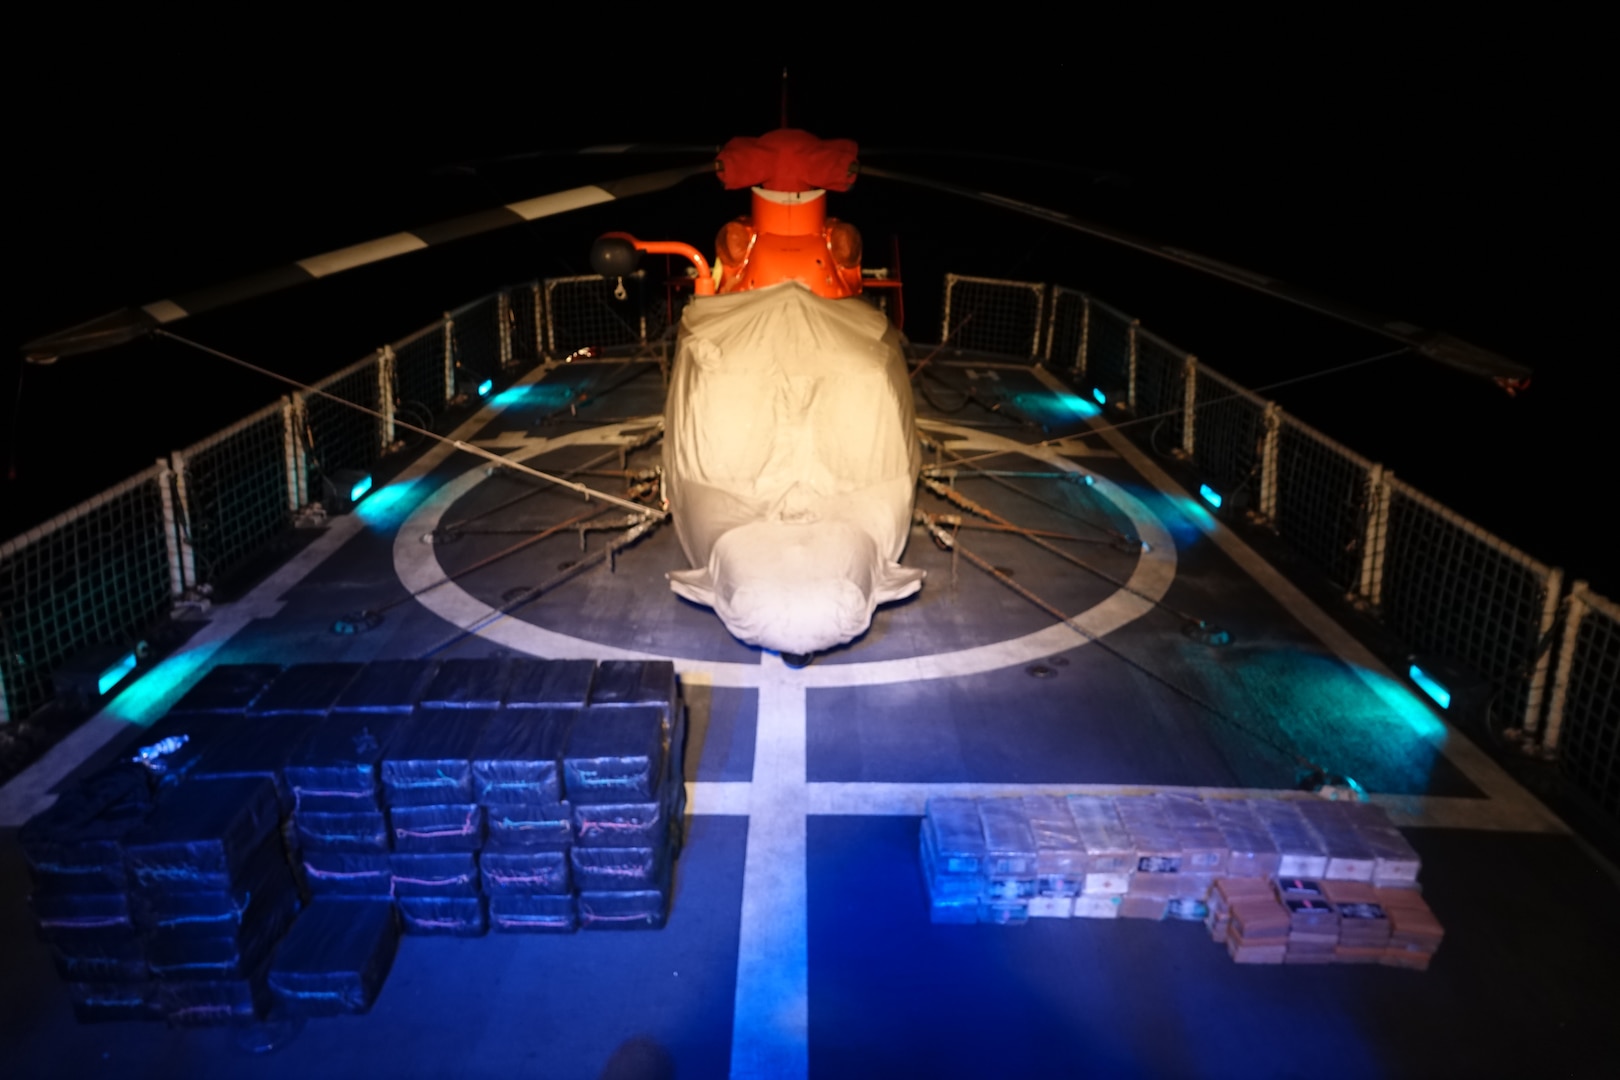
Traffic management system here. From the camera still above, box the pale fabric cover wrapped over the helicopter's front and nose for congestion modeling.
[664,282,923,654]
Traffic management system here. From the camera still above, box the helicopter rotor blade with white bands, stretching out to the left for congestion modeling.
[23,162,714,364]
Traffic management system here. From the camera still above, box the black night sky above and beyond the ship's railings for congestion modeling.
[9,25,1620,594]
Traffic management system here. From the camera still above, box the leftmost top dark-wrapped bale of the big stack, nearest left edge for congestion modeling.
[16,764,152,894]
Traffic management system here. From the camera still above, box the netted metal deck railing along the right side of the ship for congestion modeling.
[944,275,1620,818]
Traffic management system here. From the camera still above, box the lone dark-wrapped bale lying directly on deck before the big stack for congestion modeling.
[269,900,399,1017]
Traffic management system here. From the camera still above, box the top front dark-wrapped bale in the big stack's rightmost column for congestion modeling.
[562,706,664,803]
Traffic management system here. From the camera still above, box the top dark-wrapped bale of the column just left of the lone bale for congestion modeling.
[123,779,280,892]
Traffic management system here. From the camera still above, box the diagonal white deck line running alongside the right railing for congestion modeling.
[1034,368,1570,832]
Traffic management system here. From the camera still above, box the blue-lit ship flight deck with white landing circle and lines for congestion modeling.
[0,358,1620,1077]
